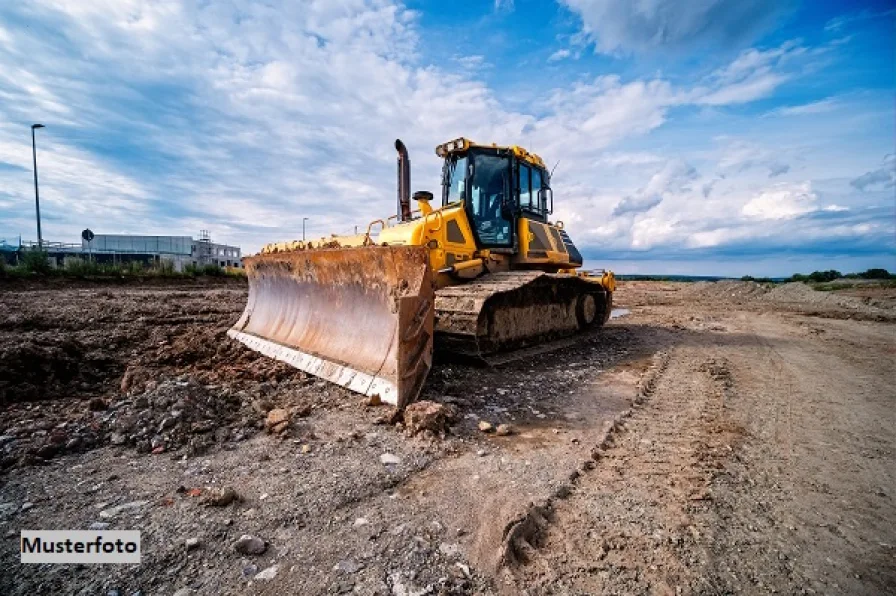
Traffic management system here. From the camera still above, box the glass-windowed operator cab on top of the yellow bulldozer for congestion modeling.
[436,139,552,248]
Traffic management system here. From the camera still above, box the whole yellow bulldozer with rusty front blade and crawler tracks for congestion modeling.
[228,138,616,409]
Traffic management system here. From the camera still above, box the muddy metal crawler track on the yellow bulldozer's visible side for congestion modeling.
[435,271,611,366]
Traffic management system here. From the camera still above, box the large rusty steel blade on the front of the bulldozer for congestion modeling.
[227,246,434,408]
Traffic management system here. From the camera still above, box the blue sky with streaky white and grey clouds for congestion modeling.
[0,0,896,276]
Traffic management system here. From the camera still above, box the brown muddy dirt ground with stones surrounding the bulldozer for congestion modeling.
[0,282,896,596]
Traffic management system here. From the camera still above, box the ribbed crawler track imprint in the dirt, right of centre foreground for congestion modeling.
[504,347,742,594]
